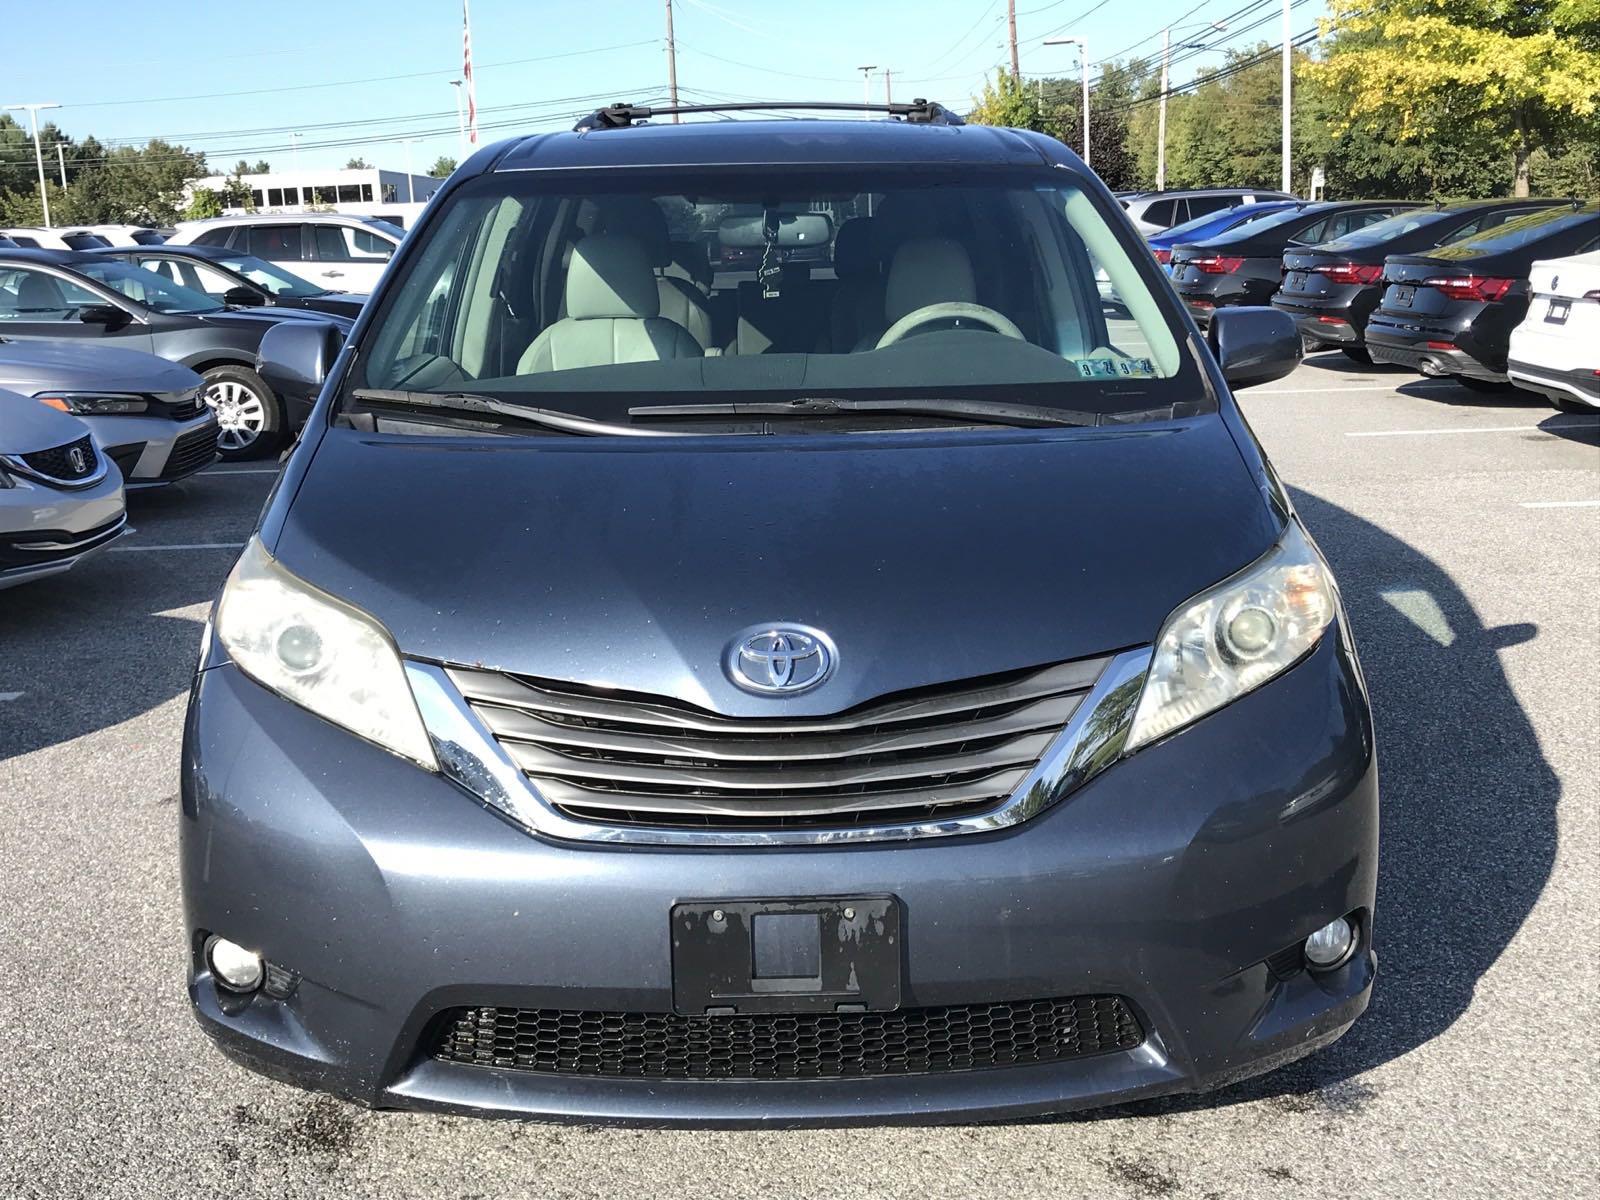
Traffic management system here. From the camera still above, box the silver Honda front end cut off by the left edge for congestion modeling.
[0,390,128,589]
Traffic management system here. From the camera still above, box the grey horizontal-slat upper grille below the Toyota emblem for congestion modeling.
[448,659,1107,829]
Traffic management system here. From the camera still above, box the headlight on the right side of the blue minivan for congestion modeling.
[1126,518,1338,750]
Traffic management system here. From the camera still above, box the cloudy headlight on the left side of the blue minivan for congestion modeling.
[216,538,438,771]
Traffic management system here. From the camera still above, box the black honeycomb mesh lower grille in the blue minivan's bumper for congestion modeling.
[434,995,1144,1080]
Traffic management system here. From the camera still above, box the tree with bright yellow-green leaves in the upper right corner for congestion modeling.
[1307,0,1600,195]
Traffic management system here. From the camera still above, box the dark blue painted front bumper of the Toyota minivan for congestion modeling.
[181,629,1378,1125]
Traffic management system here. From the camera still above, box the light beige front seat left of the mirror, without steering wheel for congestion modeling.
[517,234,701,374]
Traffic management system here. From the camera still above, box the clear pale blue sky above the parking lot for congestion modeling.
[0,0,1323,173]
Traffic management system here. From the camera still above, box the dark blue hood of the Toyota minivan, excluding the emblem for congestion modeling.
[269,416,1280,715]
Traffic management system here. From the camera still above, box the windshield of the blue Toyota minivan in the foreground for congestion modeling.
[346,168,1205,419]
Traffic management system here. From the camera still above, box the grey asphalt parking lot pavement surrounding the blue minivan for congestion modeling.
[0,355,1600,1200]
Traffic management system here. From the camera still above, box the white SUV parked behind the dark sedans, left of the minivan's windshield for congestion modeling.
[166,213,405,293]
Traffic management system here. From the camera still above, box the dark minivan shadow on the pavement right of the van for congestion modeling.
[1078,491,1562,1120]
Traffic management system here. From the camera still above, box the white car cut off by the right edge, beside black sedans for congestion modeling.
[1506,250,1600,413]
